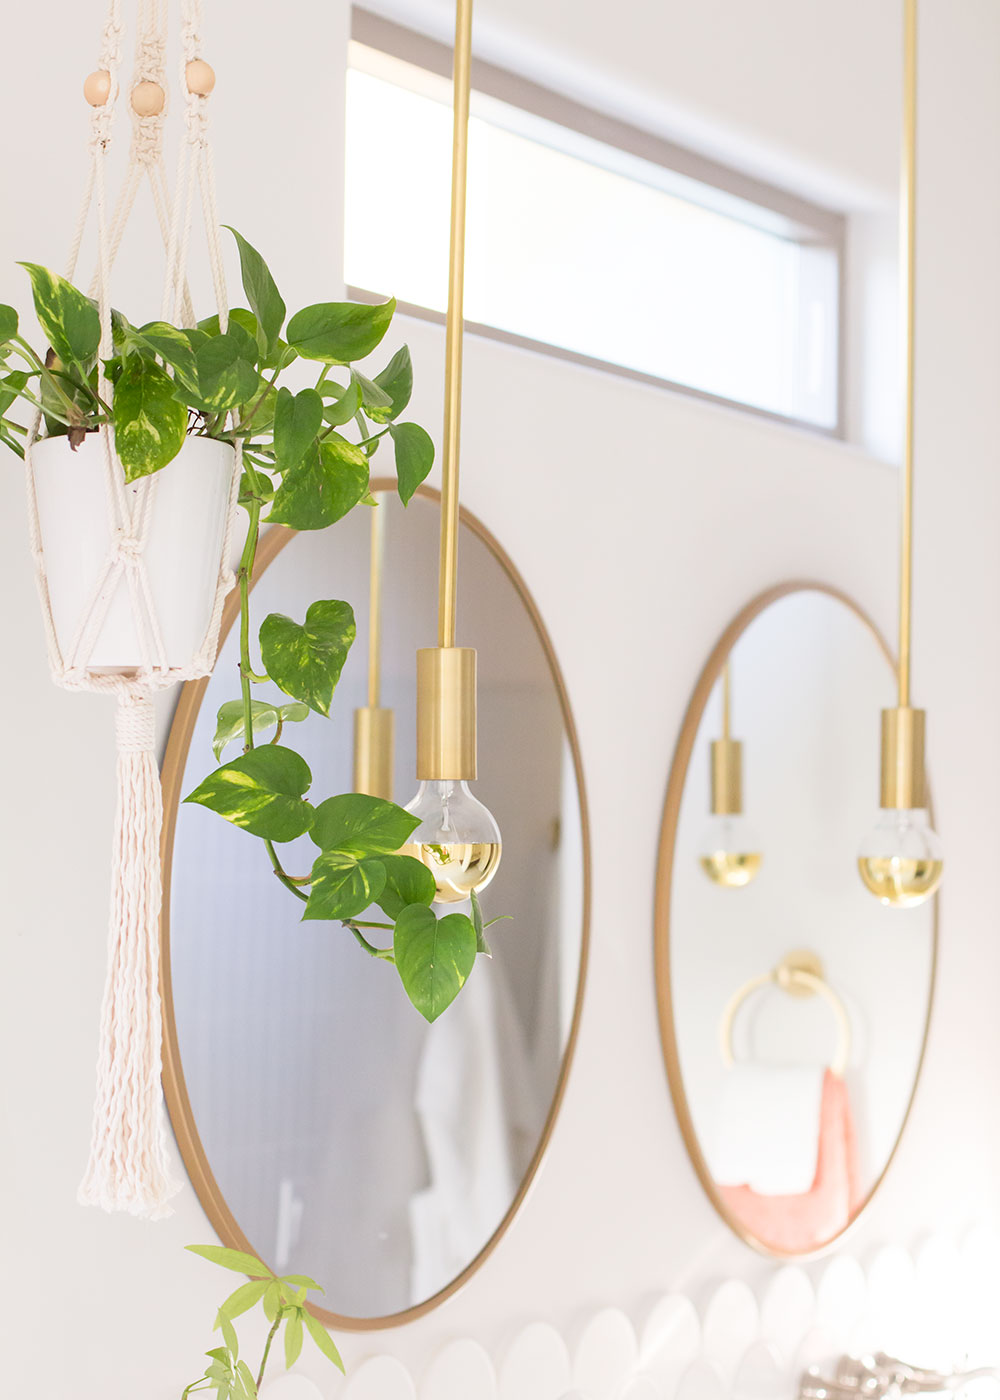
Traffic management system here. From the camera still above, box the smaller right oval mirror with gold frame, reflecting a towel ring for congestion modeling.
[655,581,937,1259]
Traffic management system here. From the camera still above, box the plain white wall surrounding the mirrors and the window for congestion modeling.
[0,0,1000,1400]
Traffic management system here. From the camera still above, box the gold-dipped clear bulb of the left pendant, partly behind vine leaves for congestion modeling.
[401,778,500,904]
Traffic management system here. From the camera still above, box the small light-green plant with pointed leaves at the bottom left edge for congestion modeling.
[181,1245,343,1400]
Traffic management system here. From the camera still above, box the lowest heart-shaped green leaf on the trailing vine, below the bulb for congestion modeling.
[392,904,476,1021]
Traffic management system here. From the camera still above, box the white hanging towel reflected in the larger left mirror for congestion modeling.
[410,962,524,1302]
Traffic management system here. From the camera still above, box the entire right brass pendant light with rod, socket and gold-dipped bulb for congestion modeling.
[857,0,944,909]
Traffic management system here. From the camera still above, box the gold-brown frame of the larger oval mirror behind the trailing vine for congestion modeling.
[160,477,591,1331]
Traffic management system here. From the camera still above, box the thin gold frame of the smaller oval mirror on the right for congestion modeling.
[653,580,940,1260]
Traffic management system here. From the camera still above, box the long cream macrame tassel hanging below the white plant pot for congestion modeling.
[78,687,179,1219]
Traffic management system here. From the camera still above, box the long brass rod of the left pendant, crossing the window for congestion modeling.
[437,0,472,647]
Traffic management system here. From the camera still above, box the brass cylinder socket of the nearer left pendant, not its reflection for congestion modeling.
[417,647,476,783]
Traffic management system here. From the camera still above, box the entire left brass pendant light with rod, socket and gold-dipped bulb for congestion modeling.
[403,0,500,904]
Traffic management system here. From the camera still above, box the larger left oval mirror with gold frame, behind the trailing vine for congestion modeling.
[161,480,590,1329]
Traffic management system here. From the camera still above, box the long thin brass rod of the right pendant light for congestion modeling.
[899,0,917,708]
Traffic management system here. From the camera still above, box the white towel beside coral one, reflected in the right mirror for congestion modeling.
[709,1064,824,1196]
